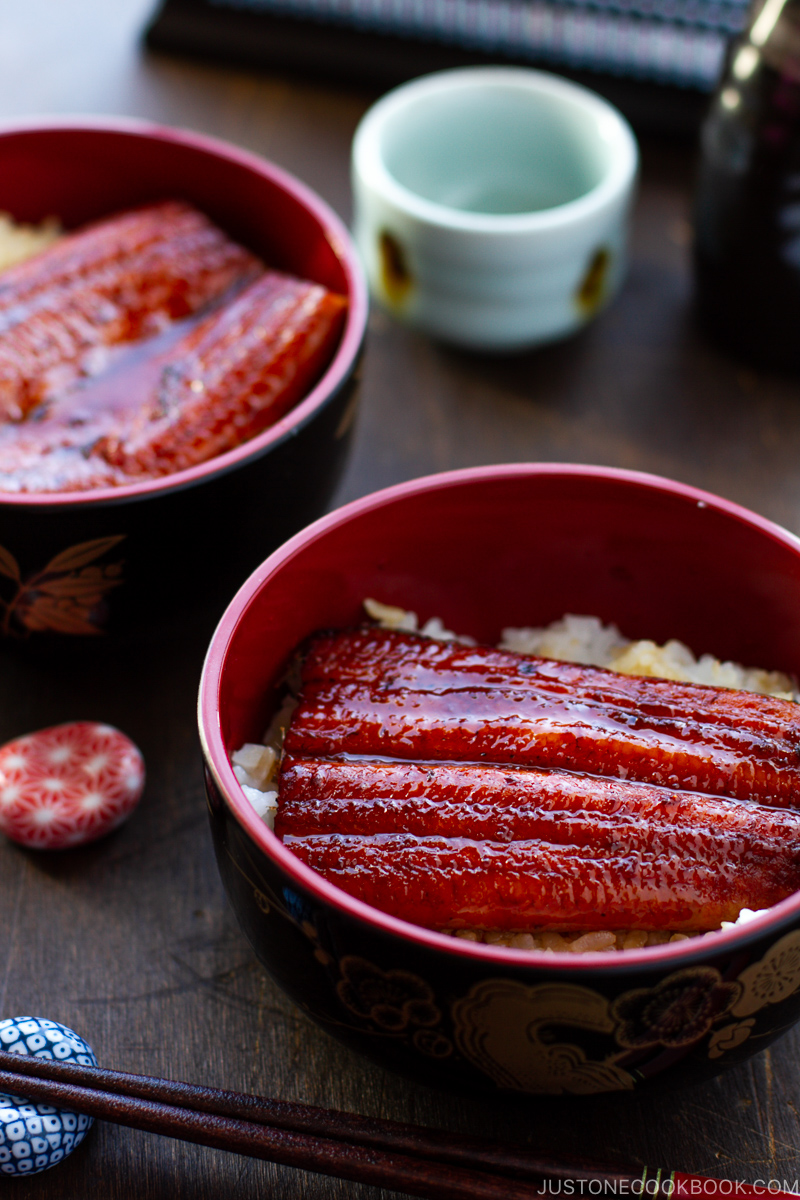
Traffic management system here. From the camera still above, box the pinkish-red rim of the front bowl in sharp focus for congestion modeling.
[198,462,800,976]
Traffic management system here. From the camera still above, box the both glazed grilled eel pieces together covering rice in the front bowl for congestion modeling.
[276,629,800,931]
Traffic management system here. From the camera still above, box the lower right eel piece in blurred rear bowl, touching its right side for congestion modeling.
[94,271,347,476]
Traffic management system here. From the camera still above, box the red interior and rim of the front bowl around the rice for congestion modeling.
[200,464,800,966]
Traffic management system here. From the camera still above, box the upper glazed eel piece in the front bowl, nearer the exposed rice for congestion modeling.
[285,629,800,808]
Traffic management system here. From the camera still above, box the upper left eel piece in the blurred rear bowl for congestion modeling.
[0,200,261,421]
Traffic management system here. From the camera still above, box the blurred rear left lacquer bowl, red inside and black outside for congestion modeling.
[0,118,367,640]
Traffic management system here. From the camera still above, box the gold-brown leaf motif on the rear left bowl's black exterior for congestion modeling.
[0,534,126,636]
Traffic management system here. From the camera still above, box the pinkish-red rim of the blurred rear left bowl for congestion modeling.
[0,114,368,509]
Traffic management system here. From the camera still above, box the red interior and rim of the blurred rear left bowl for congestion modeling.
[0,118,367,504]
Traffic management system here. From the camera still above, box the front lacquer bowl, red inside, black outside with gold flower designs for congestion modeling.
[199,464,800,1094]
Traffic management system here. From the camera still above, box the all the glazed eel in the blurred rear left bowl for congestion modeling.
[0,200,347,492]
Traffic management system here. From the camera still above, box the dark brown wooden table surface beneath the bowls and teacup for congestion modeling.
[0,0,800,1200]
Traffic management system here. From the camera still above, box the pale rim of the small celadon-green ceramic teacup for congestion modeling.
[351,66,639,241]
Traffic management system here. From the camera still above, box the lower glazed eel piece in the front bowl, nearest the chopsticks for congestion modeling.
[275,756,800,931]
